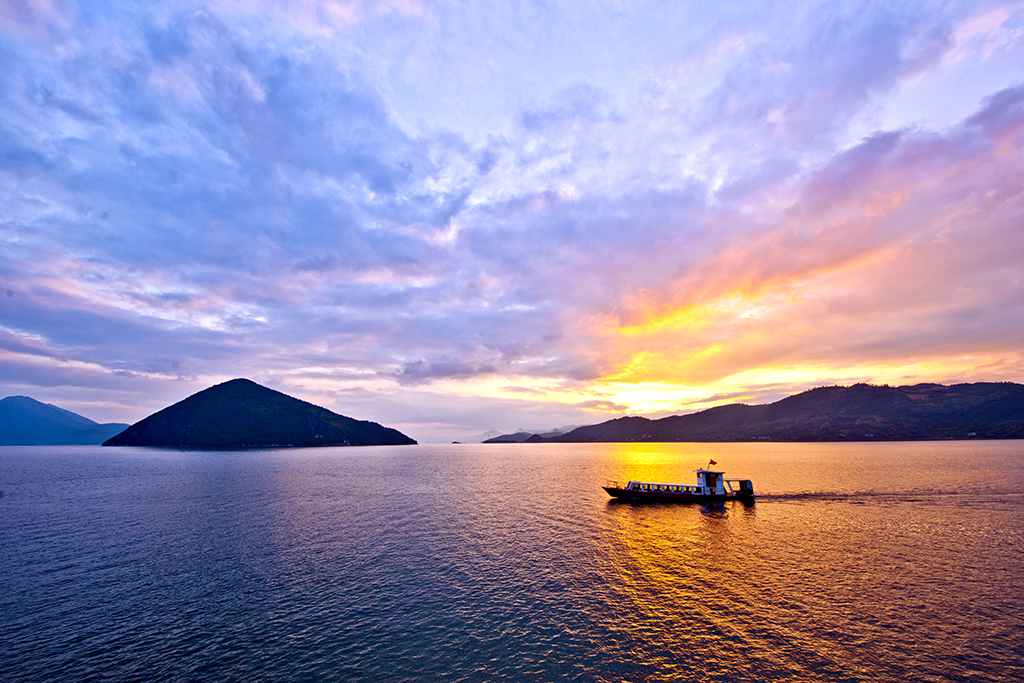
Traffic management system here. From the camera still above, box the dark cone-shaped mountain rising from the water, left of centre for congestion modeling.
[103,379,416,449]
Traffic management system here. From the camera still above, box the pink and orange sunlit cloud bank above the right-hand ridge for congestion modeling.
[593,81,1024,383]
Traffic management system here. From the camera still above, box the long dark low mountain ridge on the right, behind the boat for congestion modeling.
[489,382,1024,442]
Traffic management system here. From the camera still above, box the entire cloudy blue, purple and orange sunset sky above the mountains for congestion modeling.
[0,0,1024,440]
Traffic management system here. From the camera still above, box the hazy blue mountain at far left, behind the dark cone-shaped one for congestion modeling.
[0,396,128,445]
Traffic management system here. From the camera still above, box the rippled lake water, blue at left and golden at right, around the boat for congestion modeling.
[0,441,1024,682]
